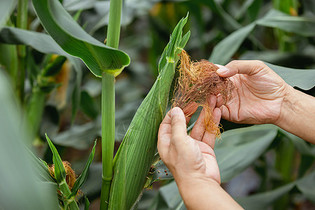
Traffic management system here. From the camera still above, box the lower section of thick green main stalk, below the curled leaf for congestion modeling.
[101,72,115,209]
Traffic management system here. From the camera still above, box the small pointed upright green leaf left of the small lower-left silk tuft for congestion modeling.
[45,134,66,184]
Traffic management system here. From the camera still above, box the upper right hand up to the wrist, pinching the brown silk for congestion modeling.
[217,60,291,124]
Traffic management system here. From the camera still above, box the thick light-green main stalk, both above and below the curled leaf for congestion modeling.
[101,0,122,210]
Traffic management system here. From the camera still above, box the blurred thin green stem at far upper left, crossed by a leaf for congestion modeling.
[16,0,28,104]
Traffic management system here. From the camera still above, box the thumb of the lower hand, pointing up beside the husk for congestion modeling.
[171,107,187,146]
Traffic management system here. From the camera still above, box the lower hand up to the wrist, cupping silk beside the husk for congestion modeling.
[158,96,221,185]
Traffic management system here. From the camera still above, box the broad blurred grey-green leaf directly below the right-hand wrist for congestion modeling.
[214,125,278,182]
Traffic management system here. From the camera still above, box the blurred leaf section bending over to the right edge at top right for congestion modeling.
[257,10,315,37]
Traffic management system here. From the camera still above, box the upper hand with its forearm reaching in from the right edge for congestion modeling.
[217,60,315,144]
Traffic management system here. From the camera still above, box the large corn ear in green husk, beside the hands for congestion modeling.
[109,15,190,209]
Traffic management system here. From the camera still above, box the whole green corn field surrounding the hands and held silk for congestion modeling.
[0,0,315,210]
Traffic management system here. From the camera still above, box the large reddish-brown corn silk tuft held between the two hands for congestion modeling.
[173,50,234,136]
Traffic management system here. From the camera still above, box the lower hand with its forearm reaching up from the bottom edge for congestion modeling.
[158,96,241,209]
